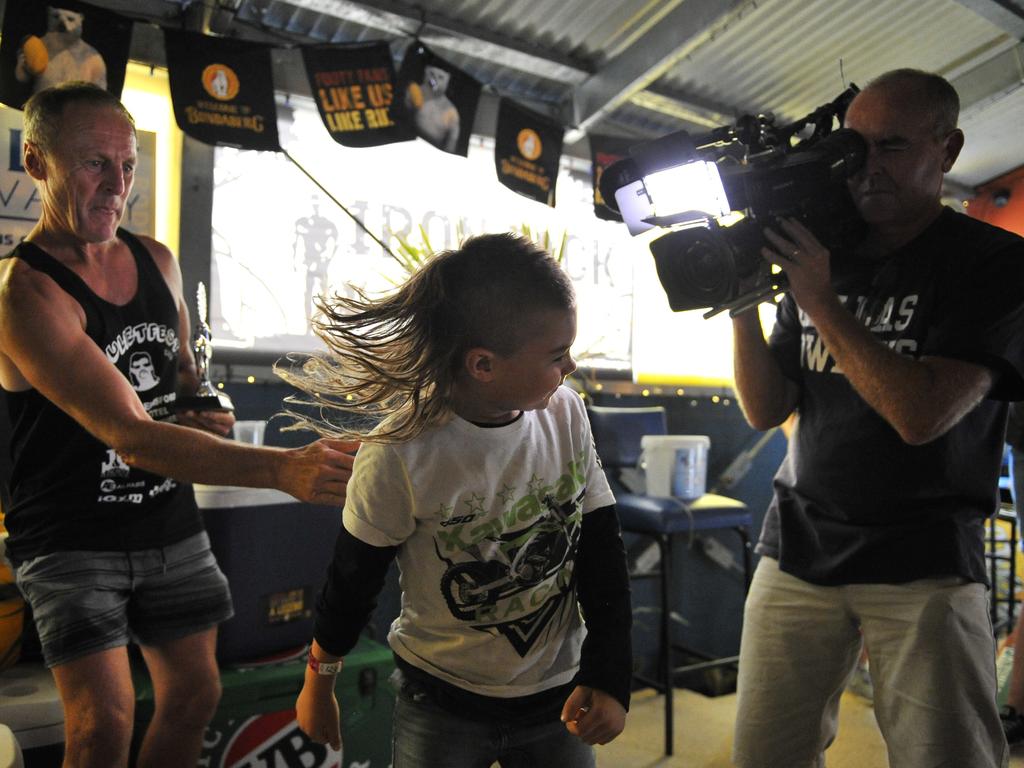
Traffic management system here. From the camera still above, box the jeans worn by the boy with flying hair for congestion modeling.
[391,671,595,768]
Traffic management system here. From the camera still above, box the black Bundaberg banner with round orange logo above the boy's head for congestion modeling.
[495,98,564,208]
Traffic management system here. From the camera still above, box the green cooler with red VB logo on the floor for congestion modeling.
[135,637,394,768]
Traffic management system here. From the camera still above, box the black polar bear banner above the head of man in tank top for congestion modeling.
[0,0,132,110]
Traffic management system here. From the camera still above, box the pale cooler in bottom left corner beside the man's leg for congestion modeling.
[0,662,63,768]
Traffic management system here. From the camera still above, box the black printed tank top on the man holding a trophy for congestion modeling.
[4,229,203,562]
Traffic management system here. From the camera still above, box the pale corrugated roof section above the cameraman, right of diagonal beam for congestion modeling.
[658,0,1008,120]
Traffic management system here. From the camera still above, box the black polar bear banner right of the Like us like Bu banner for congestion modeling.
[398,41,480,157]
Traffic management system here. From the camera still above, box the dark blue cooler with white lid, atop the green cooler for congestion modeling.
[195,485,341,663]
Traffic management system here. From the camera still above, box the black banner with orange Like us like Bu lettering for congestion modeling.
[302,41,416,146]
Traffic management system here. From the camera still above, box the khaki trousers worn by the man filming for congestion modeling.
[733,557,1009,768]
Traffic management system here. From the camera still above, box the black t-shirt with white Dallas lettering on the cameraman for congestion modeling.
[758,209,1024,585]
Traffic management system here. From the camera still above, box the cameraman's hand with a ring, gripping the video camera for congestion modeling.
[761,218,836,316]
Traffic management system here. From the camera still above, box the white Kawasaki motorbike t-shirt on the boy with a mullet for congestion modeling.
[343,387,614,697]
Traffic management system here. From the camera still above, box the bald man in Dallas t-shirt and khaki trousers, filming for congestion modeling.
[734,70,1024,768]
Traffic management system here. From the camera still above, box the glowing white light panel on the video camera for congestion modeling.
[643,161,731,223]
